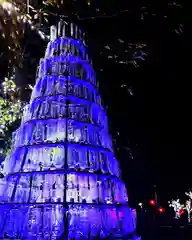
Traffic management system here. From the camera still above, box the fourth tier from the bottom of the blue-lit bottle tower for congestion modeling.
[13,119,112,150]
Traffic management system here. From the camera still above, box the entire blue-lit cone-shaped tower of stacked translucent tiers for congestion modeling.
[0,21,135,240]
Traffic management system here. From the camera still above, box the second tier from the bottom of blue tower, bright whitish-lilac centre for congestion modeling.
[0,170,128,205]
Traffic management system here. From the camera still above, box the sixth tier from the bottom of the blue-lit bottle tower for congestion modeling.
[31,75,103,113]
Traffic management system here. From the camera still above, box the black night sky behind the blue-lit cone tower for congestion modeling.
[0,0,192,204]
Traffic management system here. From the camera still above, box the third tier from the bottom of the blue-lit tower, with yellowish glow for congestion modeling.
[4,143,120,177]
